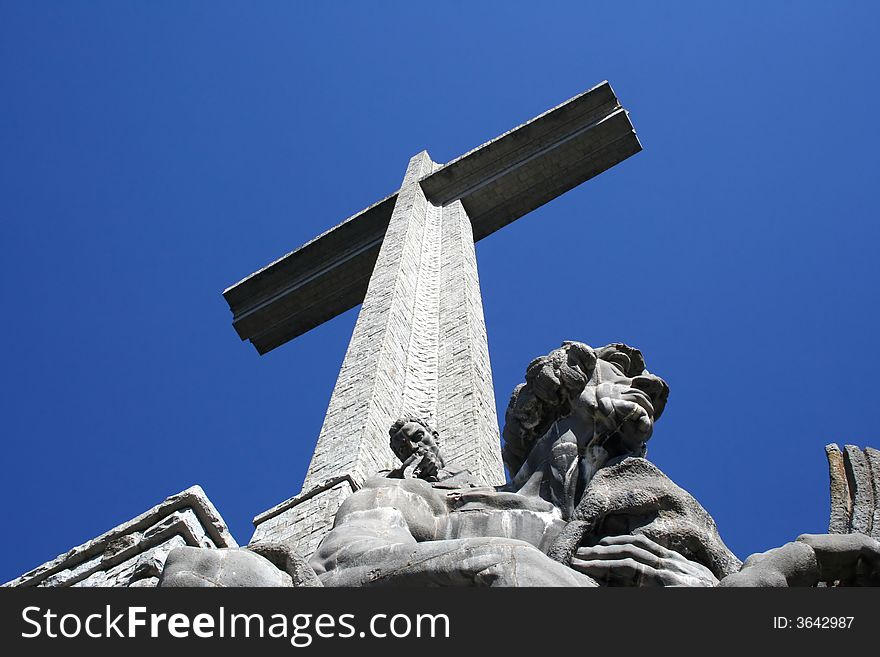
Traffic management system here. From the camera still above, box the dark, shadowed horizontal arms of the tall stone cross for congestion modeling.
[223,82,641,354]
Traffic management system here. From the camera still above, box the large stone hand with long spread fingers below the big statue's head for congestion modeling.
[571,535,718,586]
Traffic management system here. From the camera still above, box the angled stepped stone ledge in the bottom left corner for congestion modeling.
[4,486,237,587]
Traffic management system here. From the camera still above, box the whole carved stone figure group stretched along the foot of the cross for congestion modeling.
[160,342,880,587]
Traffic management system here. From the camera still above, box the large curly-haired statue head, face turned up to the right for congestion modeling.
[502,342,669,476]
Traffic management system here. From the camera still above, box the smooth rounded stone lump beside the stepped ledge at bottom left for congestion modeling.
[159,547,292,588]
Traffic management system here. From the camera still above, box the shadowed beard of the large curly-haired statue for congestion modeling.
[591,397,654,457]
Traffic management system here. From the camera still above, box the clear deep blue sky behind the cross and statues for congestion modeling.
[0,1,880,581]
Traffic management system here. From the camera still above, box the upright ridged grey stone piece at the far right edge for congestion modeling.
[825,444,880,539]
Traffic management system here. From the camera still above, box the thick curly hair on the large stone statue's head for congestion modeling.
[501,342,662,476]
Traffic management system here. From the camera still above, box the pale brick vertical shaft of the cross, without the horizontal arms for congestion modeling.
[254,152,504,555]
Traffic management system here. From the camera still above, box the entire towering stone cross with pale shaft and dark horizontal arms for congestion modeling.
[223,82,641,556]
